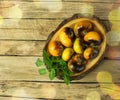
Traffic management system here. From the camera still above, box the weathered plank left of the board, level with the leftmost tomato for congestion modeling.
[0,41,45,56]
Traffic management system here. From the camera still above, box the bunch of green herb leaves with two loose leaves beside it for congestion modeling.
[36,50,73,85]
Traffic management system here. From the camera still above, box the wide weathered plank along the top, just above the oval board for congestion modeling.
[1,1,119,20]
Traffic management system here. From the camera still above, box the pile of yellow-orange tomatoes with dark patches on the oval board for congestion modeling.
[47,20,102,73]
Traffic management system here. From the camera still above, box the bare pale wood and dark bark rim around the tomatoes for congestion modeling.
[44,14,106,79]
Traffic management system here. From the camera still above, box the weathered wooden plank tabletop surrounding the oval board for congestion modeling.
[0,0,120,100]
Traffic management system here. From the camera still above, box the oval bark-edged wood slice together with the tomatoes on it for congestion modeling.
[44,14,106,79]
